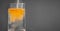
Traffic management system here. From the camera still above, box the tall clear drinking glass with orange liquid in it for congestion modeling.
[8,3,25,31]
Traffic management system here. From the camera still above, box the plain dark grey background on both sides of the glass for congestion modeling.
[0,0,60,31]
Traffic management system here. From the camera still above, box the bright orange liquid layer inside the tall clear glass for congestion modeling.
[8,8,25,22]
